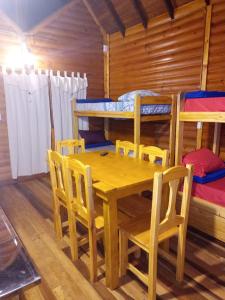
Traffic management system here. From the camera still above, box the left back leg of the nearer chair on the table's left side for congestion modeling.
[68,210,78,261]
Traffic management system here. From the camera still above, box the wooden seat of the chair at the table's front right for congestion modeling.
[119,213,178,252]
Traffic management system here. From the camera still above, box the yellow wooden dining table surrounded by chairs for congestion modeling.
[70,151,166,289]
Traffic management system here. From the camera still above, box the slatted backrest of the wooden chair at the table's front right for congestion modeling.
[150,165,193,247]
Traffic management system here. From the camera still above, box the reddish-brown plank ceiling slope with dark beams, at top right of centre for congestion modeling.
[82,0,194,35]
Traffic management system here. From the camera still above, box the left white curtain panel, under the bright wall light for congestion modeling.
[3,70,51,179]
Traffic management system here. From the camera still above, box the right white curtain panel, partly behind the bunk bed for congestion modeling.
[50,72,88,141]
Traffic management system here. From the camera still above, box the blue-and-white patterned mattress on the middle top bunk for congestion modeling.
[77,101,171,115]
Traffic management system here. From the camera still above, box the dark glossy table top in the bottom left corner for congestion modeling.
[0,207,40,298]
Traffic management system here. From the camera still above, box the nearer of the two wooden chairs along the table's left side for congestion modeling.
[63,157,128,282]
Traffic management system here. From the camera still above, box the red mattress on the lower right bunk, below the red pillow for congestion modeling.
[192,177,225,207]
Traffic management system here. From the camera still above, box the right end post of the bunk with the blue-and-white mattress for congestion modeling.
[169,95,177,166]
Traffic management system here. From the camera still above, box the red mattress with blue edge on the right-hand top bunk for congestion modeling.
[184,91,225,112]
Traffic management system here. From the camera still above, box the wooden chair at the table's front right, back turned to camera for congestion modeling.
[119,165,192,300]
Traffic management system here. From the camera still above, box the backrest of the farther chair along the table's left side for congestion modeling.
[48,150,66,202]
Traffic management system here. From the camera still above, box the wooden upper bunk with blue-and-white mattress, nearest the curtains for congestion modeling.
[73,95,176,165]
